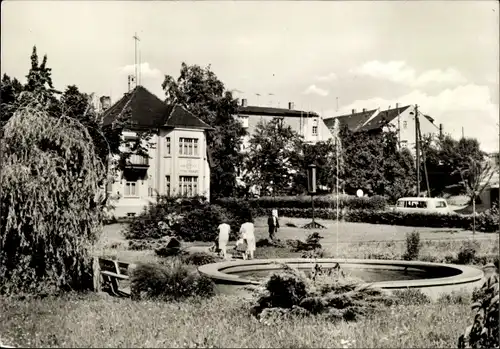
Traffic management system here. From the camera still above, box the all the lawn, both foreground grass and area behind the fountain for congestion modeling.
[0,218,498,348]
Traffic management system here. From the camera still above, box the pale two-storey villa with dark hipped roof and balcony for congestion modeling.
[103,86,212,217]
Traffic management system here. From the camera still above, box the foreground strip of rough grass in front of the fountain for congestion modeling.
[0,294,471,348]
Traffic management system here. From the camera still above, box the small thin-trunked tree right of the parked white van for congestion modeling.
[456,156,494,234]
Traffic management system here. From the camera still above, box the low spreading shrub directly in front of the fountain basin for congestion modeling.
[252,264,392,322]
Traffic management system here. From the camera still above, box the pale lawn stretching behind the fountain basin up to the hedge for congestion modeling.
[95,217,498,262]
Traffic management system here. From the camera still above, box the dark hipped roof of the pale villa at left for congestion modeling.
[103,86,212,130]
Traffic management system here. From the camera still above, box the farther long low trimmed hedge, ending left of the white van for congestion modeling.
[214,195,387,211]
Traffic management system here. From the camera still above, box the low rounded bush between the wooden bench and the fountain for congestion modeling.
[130,260,215,301]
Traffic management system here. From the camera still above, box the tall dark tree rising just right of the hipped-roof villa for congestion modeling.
[162,63,246,198]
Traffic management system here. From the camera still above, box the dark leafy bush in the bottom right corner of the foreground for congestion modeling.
[458,274,500,348]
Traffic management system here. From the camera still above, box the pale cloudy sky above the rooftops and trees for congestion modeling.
[1,0,499,151]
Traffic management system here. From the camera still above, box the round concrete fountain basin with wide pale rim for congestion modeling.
[198,258,484,299]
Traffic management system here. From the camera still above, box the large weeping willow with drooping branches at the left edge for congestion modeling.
[0,100,105,294]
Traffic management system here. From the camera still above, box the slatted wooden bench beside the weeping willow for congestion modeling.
[99,258,131,297]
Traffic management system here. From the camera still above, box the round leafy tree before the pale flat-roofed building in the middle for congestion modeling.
[245,119,303,194]
